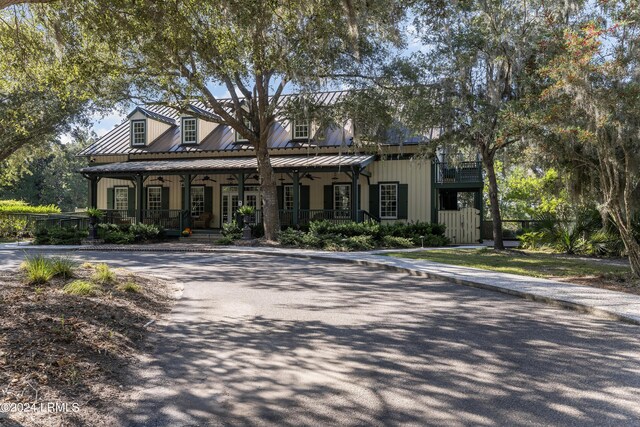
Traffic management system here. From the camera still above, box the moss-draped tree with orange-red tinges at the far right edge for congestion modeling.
[542,0,640,277]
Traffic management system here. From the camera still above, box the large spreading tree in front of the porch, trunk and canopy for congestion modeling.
[41,0,402,239]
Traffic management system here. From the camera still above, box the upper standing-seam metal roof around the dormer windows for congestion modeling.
[79,91,353,156]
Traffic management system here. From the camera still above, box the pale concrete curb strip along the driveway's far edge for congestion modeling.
[0,246,640,325]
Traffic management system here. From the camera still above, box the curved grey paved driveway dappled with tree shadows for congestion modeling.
[0,252,640,426]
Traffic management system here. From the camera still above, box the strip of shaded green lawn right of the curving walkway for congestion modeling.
[386,248,630,280]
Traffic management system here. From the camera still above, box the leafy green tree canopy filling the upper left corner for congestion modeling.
[0,2,126,162]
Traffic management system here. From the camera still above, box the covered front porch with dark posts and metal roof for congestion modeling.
[81,155,377,230]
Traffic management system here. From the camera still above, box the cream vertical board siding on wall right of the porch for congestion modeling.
[362,160,431,224]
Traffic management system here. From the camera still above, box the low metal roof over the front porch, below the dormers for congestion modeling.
[80,155,375,176]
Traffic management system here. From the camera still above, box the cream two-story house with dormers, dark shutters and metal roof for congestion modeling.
[80,91,482,243]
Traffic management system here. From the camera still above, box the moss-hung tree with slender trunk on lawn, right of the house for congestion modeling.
[404,0,571,249]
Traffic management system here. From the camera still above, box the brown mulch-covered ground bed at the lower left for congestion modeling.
[0,266,177,426]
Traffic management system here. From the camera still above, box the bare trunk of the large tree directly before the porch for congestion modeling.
[256,140,280,240]
